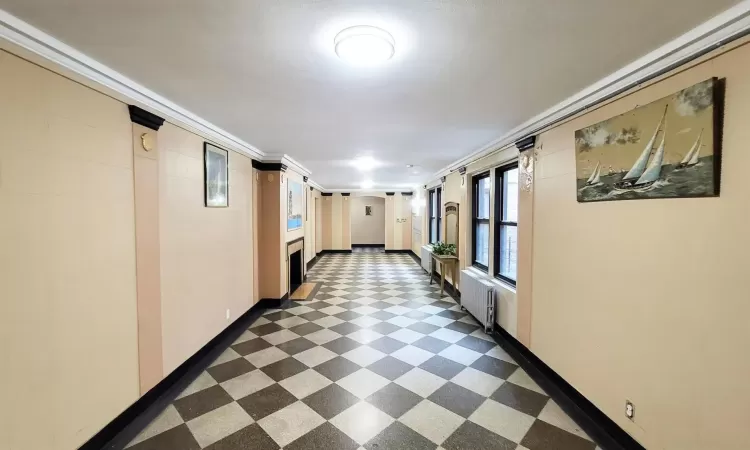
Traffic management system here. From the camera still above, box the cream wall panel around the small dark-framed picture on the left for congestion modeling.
[159,123,257,374]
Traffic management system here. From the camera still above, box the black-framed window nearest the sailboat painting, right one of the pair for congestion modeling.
[494,164,518,286]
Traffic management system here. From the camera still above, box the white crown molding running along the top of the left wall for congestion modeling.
[0,9,320,183]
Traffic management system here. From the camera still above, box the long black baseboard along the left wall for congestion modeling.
[79,295,288,450]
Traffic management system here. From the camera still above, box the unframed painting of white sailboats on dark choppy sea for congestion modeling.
[575,78,723,202]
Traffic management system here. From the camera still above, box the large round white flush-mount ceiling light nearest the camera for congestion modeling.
[333,25,396,66]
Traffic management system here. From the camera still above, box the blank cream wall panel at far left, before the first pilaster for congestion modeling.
[0,51,139,450]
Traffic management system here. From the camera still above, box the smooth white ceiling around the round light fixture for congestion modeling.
[0,0,738,189]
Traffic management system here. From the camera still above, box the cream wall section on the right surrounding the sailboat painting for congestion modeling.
[531,40,750,450]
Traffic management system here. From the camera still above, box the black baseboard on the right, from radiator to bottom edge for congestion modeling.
[493,326,645,450]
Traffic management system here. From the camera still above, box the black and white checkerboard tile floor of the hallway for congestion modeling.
[128,252,597,450]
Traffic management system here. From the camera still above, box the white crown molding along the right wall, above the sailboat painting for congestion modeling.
[431,0,750,180]
